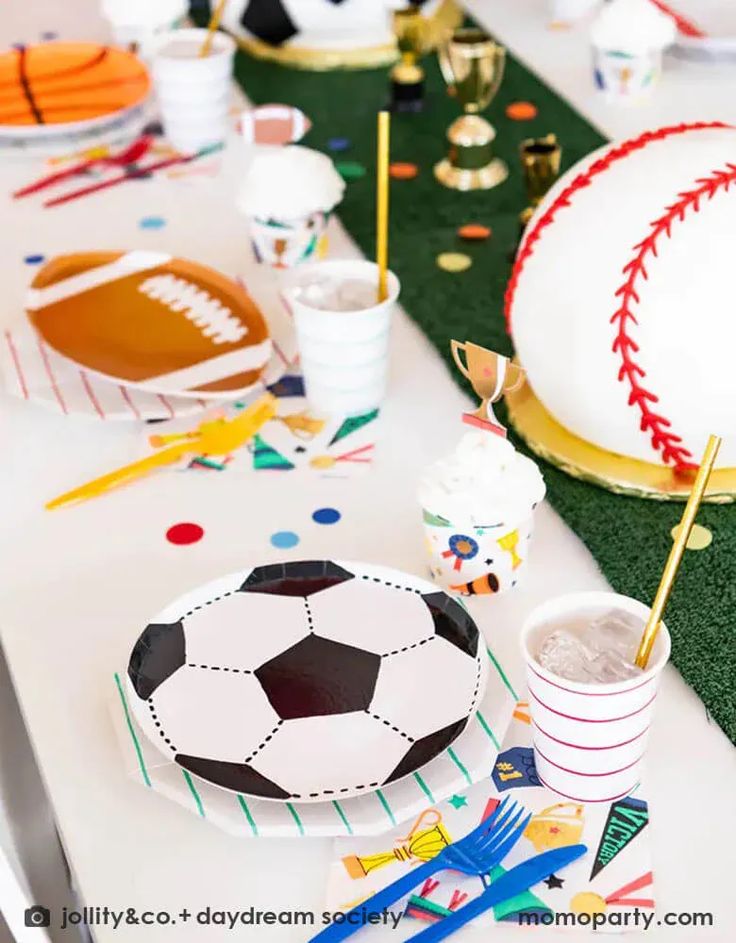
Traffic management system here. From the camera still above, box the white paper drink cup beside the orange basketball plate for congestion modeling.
[152,29,235,152]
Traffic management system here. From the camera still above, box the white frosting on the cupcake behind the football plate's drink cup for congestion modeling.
[238,144,345,220]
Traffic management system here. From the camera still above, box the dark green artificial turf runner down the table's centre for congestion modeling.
[221,24,736,749]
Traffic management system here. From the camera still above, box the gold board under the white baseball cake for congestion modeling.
[505,383,736,504]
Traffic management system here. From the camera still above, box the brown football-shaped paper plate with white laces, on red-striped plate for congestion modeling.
[26,251,271,399]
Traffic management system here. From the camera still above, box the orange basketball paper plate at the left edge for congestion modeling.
[0,42,151,138]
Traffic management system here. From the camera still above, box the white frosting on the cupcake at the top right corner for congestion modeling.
[590,0,677,55]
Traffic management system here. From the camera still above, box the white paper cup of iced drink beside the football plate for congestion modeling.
[286,259,400,416]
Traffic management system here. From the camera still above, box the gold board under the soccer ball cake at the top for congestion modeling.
[232,0,463,72]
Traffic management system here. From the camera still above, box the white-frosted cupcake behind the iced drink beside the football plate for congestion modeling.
[238,144,345,268]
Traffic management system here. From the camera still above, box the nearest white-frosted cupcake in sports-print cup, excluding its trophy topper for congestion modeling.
[419,431,545,596]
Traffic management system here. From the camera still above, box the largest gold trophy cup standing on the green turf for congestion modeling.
[434,27,509,190]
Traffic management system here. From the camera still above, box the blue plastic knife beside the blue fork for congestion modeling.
[411,845,588,943]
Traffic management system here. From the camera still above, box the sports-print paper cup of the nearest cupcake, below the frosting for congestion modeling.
[422,507,534,596]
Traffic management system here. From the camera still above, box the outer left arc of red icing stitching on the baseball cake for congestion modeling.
[504,121,732,333]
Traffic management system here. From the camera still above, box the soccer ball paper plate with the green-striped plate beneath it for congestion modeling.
[114,561,514,835]
